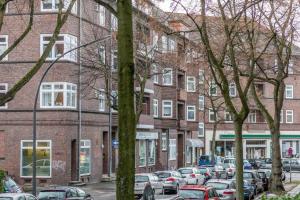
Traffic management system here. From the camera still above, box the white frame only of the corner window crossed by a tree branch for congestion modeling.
[40,34,78,62]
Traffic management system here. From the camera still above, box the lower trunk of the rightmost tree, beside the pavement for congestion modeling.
[270,128,285,194]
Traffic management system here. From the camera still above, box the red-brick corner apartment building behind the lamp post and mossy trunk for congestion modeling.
[0,0,204,184]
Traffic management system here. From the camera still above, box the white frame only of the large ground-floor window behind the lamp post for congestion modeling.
[20,140,52,178]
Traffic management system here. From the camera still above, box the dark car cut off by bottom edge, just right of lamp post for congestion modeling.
[38,186,93,200]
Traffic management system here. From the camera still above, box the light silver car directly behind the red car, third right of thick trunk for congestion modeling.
[178,167,205,185]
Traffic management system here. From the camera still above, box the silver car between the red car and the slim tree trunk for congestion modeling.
[205,179,236,200]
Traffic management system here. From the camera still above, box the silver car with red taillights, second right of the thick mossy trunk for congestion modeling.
[154,171,186,194]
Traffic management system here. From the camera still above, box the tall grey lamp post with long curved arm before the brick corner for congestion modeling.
[32,35,111,196]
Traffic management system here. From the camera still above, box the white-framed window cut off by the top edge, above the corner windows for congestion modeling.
[41,0,77,14]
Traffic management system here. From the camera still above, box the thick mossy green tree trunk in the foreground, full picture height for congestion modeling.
[116,0,136,200]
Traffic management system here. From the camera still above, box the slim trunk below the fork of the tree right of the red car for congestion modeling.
[234,122,244,200]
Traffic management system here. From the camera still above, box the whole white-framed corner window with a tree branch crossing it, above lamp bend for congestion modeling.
[40,34,77,62]
